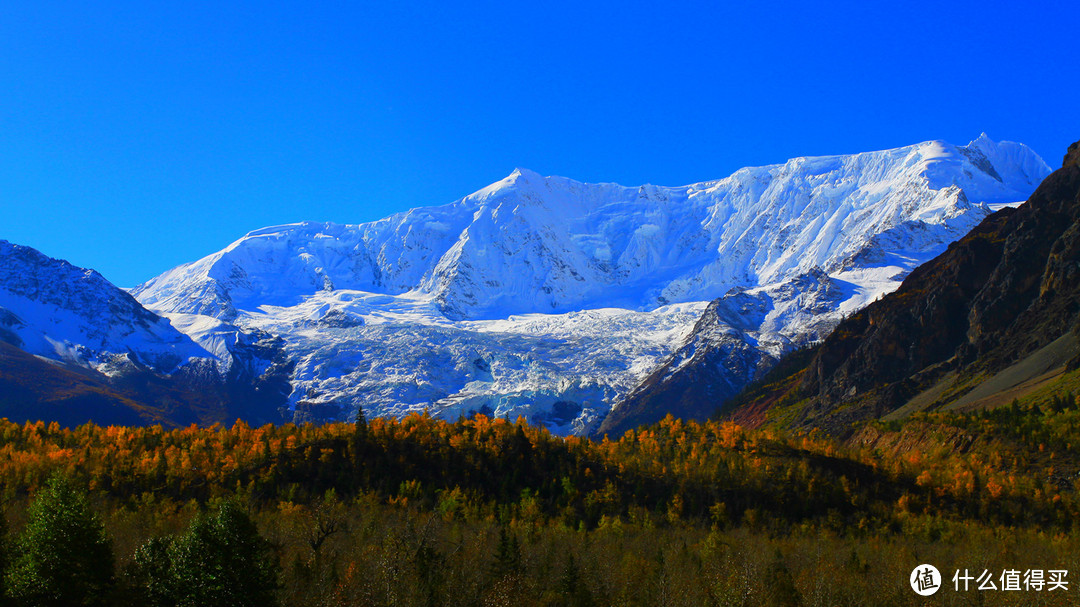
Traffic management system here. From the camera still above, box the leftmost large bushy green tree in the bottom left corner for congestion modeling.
[6,474,113,607]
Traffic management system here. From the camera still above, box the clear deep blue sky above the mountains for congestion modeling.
[0,0,1080,286]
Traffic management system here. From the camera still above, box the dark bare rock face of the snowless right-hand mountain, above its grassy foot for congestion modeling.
[717,139,1080,432]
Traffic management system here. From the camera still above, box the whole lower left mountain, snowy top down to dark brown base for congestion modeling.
[0,241,293,426]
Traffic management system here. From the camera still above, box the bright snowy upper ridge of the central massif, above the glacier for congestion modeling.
[134,136,1050,320]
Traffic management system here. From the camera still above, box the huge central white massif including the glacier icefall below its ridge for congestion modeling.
[133,135,1050,432]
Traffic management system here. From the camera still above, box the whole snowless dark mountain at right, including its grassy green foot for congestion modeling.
[712,137,1080,432]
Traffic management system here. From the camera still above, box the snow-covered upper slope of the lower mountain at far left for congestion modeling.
[0,241,213,373]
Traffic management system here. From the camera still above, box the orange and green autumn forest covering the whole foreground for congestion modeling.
[0,394,1080,606]
